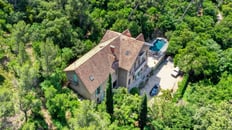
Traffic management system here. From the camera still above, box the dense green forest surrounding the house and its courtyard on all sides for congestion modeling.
[0,0,232,130]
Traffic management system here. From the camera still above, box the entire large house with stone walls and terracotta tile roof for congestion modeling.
[64,30,149,102]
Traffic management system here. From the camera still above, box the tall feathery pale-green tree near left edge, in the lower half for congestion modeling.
[17,62,41,122]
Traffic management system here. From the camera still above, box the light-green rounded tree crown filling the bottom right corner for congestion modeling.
[193,101,232,130]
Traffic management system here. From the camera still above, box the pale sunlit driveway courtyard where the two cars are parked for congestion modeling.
[141,58,181,99]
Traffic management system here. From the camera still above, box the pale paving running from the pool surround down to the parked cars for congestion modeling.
[140,38,179,102]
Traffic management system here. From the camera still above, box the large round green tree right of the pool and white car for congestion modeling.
[174,37,218,80]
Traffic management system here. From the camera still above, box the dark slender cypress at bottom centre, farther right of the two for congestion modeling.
[139,95,147,130]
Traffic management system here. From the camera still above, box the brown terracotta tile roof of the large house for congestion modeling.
[64,30,144,94]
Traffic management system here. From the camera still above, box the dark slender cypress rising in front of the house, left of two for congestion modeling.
[106,75,114,120]
